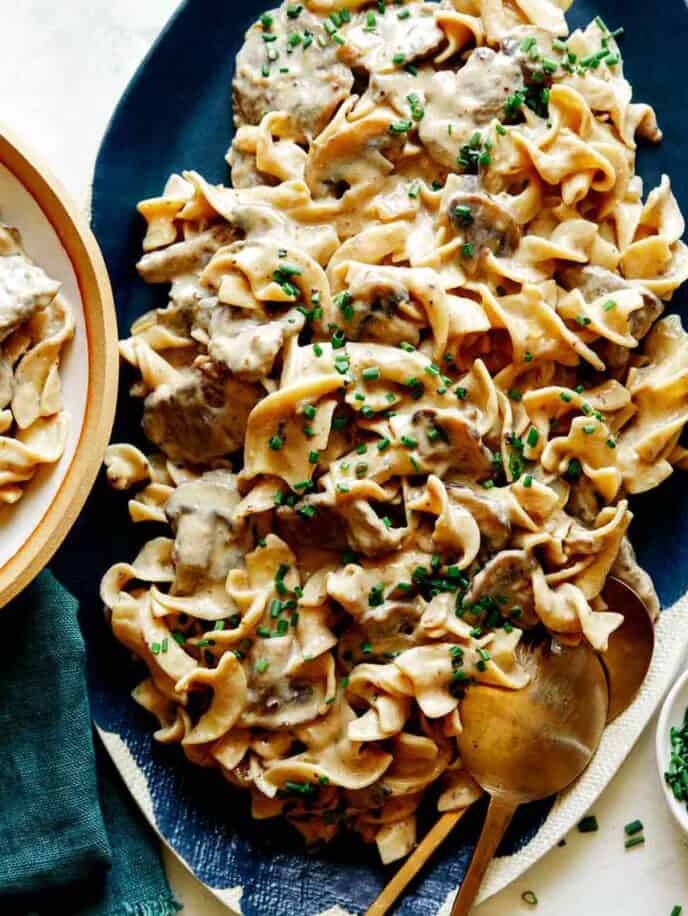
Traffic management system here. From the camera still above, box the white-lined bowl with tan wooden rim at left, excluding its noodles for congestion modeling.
[0,126,118,607]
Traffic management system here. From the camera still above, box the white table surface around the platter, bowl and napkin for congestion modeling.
[0,0,688,916]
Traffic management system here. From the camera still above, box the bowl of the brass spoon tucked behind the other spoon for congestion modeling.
[600,577,655,722]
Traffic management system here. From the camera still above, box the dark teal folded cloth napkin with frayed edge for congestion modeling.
[0,571,181,916]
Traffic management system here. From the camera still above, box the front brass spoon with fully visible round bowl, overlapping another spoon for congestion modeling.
[452,641,609,916]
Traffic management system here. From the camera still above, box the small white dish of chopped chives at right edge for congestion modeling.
[656,670,688,833]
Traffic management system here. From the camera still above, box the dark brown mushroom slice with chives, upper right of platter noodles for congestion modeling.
[448,175,521,272]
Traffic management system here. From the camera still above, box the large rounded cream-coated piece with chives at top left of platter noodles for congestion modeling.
[233,4,354,140]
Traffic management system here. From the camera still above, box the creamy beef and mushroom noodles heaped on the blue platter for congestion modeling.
[102,0,688,862]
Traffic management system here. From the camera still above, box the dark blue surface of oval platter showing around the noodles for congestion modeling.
[53,0,688,916]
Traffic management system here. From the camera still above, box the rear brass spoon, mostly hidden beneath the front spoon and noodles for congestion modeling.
[366,577,654,916]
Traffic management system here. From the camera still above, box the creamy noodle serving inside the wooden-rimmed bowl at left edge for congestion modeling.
[0,223,74,506]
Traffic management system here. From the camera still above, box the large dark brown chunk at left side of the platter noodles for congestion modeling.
[143,360,261,464]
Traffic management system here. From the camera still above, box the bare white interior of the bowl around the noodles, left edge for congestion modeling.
[0,164,89,567]
